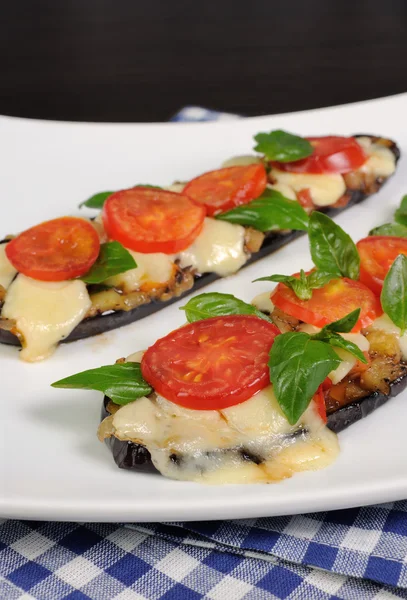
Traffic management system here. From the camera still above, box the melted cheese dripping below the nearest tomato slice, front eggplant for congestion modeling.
[109,385,339,484]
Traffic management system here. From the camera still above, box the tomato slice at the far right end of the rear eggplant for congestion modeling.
[272,135,367,173]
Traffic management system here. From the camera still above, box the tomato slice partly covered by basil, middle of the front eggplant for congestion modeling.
[271,277,382,332]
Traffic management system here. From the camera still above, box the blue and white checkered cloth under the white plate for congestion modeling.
[0,107,407,600]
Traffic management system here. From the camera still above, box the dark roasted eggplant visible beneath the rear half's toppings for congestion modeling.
[0,134,400,346]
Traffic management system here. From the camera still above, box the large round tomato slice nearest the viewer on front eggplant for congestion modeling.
[141,315,280,410]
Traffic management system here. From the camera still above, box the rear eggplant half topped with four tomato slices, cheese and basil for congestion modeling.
[0,131,400,361]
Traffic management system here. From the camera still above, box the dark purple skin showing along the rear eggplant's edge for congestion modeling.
[0,134,400,346]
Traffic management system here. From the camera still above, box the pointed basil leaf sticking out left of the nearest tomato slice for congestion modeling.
[51,362,153,404]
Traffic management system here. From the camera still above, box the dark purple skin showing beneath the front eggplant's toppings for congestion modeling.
[101,375,407,473]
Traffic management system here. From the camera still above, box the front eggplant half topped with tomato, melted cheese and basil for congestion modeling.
[51,211,407,483]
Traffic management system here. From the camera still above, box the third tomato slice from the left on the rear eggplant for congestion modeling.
[183,164,267,217]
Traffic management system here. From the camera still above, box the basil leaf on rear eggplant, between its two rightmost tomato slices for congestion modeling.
[215,189,308,231]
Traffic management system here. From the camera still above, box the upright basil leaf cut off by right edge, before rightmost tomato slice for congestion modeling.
[380,254,407,332]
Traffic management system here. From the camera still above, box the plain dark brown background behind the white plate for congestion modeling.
[0,0,407,121]
